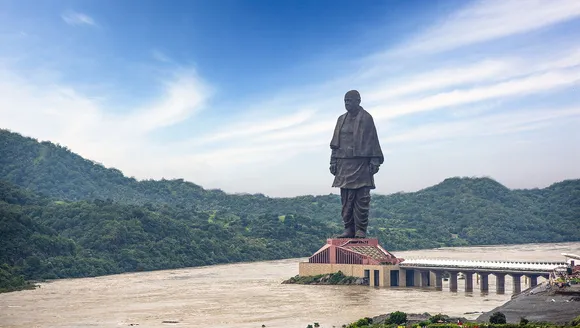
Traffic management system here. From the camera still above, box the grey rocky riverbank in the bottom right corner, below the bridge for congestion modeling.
[477,283,580,324]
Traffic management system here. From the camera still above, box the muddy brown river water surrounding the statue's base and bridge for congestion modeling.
[0,243,580,328]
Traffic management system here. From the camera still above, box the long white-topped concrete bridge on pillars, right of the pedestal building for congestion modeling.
[399,259,567,294]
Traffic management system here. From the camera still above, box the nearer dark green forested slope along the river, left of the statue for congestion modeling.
[0,181,331,291]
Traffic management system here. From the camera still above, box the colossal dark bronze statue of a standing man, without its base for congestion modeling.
[330,90,384,238]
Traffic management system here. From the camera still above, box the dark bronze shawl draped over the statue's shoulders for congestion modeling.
[330,107,384,164]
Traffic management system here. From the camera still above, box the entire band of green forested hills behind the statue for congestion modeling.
[0,130,580,290]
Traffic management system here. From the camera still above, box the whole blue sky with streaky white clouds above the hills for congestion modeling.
[0,0,580,196]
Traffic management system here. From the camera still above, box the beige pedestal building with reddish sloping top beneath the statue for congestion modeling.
[299,238,416,287]
